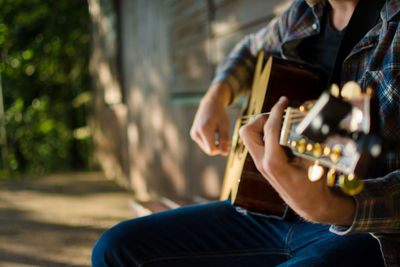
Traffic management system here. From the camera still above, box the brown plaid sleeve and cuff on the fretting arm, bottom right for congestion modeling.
[330,170,400,266]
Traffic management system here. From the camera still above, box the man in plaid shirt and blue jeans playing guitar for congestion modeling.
[92,0,400,266]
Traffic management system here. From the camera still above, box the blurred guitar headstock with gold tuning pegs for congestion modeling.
[280,82,381,195]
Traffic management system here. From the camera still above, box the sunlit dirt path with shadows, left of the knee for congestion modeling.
[0,173,134,267]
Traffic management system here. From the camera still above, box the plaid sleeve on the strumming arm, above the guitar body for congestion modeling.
[211,2,293,103]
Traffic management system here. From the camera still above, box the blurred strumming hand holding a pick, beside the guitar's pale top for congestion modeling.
[190,83,230,156]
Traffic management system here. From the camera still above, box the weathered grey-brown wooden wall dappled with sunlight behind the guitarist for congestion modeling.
[89,0,287,199]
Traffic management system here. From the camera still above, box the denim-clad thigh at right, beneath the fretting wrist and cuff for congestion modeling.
[279,222,384,267]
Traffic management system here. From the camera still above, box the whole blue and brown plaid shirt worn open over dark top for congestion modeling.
[213,0,400,266]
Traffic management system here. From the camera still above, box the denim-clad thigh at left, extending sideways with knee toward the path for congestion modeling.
[92,201,292,267]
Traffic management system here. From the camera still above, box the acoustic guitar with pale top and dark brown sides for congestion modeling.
[220,53,380,216]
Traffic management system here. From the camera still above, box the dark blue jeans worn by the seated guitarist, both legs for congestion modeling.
[92,201,383,267]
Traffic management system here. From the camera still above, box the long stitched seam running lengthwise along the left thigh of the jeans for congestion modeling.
[137,249,291,267]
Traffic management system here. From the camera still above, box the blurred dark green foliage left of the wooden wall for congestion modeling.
[0,0,90,178]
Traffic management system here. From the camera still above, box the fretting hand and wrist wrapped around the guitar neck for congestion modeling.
[239,97,355,225]
